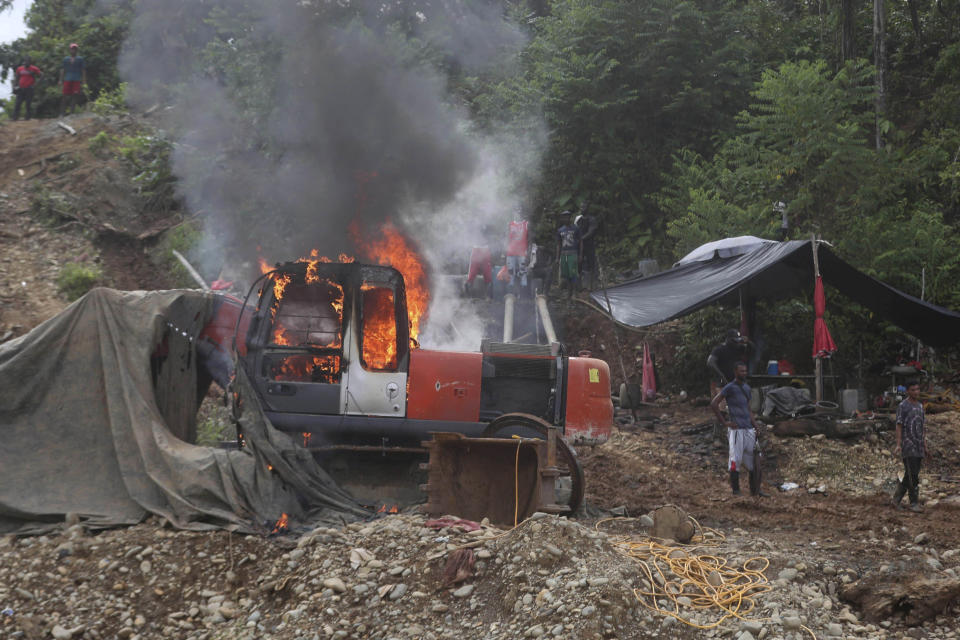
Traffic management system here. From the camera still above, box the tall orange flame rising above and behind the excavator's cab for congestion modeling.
[350,222,430,340]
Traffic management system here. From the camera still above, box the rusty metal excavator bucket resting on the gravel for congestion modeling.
[421,430,570,525]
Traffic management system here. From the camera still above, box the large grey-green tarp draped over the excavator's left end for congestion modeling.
[0,289,365,534]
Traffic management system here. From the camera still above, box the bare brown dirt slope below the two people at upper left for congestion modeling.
[0,114,181,339]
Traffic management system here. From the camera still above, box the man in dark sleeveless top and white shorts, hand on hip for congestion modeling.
[710,362,766,497]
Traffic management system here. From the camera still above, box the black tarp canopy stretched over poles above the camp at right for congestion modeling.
[590,240,960,346]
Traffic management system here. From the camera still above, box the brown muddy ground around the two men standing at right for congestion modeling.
[581,406,960,567]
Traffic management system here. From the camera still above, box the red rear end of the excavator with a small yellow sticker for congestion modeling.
[564,358,613,444]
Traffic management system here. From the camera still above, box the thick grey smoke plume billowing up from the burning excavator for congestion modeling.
[115,0,539,348]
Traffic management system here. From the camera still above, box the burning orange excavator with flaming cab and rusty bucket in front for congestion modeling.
[199,235,613,522]
